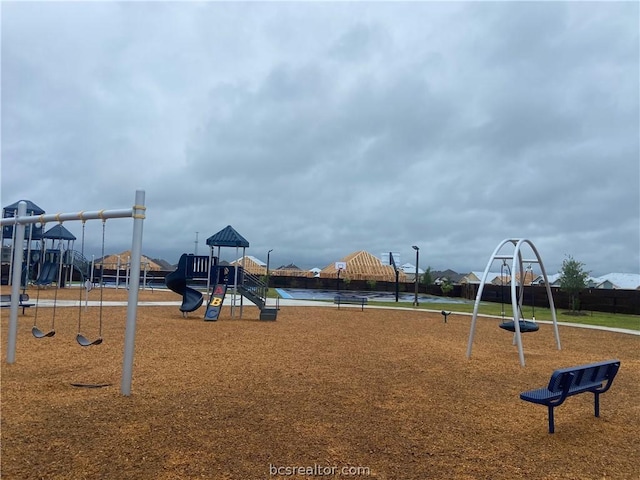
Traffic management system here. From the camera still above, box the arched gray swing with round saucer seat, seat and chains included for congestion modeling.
[467,238,561,367]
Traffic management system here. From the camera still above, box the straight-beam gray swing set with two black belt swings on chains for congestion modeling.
[0,190,146,396]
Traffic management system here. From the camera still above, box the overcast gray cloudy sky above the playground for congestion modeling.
[1,1,640,275]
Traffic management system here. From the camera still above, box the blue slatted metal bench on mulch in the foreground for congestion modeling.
[520,360,620,433]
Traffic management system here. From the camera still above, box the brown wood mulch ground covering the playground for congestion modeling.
[1,289,640,480]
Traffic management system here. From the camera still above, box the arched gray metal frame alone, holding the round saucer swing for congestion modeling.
[467,238,561,367]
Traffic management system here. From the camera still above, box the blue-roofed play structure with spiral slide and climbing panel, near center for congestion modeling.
[165,225,278,321]
